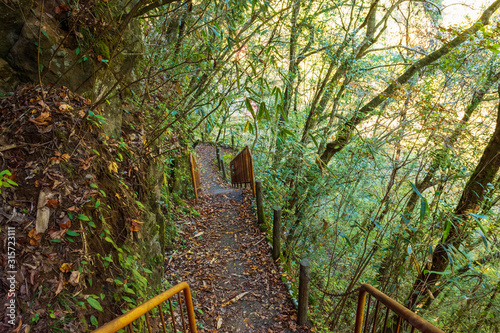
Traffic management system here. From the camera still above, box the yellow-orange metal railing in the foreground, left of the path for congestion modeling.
[92,282,196,333]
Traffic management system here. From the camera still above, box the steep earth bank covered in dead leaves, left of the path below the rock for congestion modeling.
[0,86,170,333]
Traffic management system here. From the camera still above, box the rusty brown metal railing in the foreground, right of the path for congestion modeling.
[354,284,444,333]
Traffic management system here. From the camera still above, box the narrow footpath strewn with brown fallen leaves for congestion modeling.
[166,144,303,333]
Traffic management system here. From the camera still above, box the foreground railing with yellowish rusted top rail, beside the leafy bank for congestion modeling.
[92,282,196,333]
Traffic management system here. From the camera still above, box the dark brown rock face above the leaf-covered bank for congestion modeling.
[0,0,143,138]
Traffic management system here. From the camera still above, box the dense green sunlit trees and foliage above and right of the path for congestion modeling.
[0,0,500,332]
